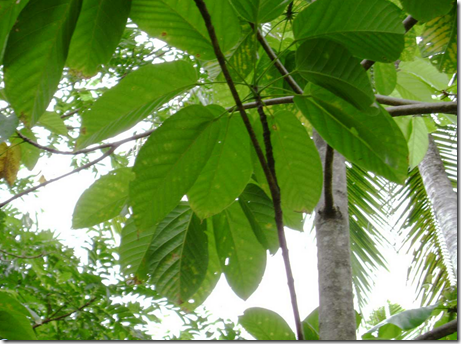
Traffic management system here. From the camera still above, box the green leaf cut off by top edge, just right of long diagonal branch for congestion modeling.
[230,0,291,24]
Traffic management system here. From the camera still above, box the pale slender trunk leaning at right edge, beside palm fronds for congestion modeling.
[418,135,458,275]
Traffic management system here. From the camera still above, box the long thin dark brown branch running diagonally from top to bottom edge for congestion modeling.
[195,0,304,340]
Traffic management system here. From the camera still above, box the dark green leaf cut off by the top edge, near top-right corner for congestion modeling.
[400,0,453,22]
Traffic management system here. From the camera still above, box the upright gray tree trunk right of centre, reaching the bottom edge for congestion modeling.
[314,132,356,340]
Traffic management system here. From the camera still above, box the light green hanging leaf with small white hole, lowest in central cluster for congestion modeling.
[213,203,266,300]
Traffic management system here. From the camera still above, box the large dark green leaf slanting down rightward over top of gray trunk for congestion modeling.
[295,85,408,183]
